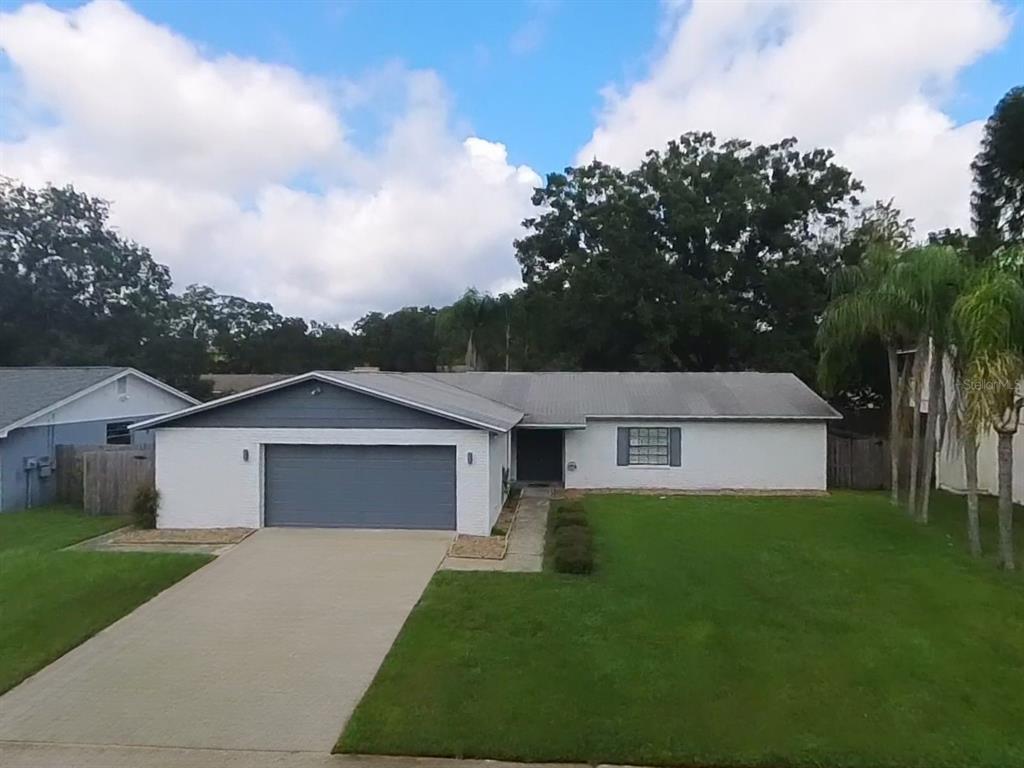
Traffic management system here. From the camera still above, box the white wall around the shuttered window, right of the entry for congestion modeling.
[565,419,826,490]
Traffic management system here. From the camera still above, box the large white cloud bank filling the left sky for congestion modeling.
[0,0,540,323]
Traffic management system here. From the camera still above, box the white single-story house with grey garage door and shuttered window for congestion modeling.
[133,371,840,535]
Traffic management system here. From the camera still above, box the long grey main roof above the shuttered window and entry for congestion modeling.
[411,372,840,425]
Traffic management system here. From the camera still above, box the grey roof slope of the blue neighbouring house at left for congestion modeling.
[0,366,130,431]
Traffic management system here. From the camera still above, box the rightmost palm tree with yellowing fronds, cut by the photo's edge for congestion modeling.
[953,259,1024,570]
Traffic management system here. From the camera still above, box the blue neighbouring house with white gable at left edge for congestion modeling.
[0,367,197,512]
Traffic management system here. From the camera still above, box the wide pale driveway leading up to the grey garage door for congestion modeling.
[0,528,451,752]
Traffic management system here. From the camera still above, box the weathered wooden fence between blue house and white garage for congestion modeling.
[56,445,155,515]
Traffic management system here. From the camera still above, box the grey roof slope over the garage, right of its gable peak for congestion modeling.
[316,371,523,430]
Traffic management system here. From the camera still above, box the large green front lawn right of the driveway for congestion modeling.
[338,493,1024,768]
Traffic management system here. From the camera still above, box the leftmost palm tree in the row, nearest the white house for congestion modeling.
[817,241,912,505]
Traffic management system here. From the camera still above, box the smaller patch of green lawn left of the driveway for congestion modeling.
[0,508,210,693]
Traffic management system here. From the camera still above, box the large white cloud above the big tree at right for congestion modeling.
[578,0,1011,234]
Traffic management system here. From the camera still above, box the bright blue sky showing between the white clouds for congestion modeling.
[34,0,1024,172]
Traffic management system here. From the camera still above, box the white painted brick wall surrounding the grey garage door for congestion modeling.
[156,427,490,536]
